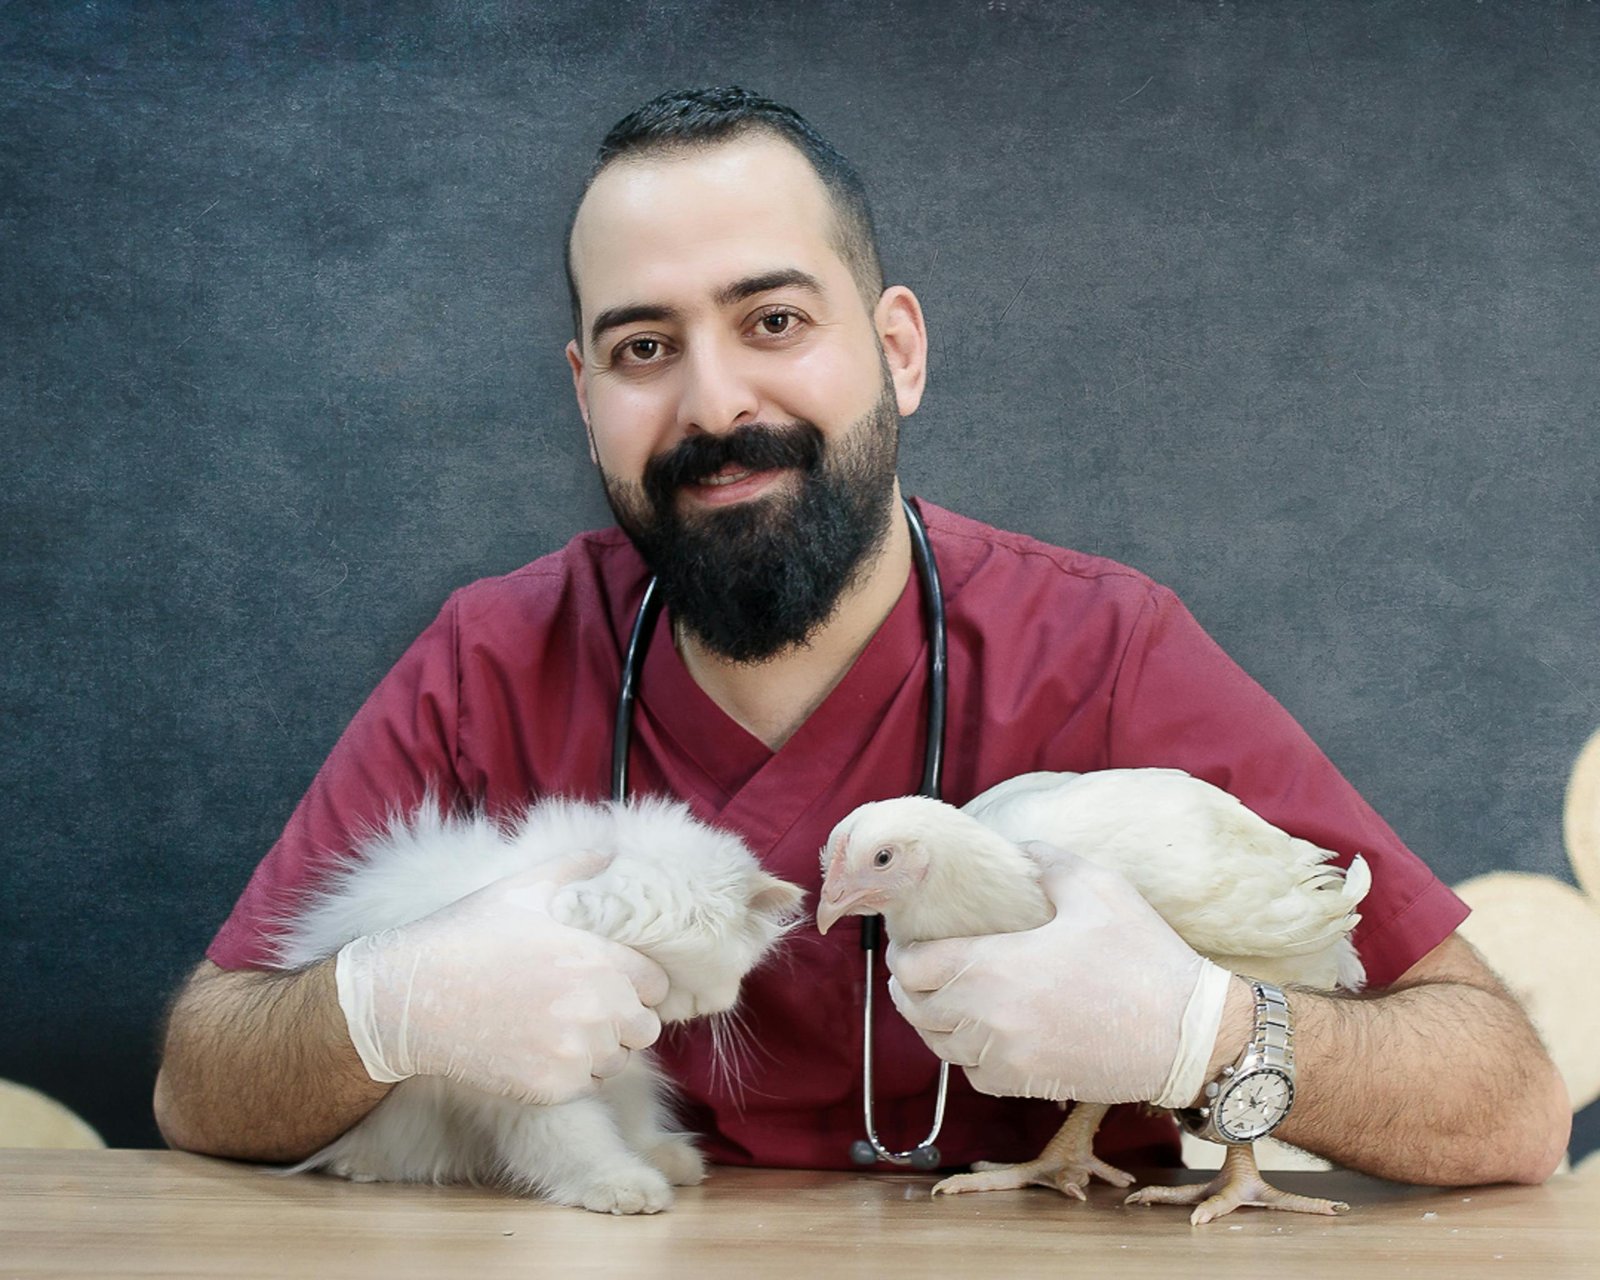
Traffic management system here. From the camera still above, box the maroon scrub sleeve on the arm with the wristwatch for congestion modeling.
[1110,584,1467,987]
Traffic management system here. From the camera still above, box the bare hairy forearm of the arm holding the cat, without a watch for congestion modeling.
[155,960,389,1162]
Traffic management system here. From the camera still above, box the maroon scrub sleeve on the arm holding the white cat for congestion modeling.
[206,597,464,970]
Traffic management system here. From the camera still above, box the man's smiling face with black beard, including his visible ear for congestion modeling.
[568,134,923,661]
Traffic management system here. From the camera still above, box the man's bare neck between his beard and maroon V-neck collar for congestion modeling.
[674,483,912,750]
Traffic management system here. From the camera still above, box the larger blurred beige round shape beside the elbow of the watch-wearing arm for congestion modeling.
[1456,870,1600,1110]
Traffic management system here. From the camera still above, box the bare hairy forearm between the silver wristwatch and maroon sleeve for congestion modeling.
[1254,939,1571,1186]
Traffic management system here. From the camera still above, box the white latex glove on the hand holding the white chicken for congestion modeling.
[885,845,1232,1107]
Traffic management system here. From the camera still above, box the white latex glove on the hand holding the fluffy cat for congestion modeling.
[334,854,667,1102]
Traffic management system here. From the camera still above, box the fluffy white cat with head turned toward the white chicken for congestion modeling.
[277,800,802,1213]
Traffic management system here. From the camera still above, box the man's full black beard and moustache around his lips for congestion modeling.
[600,376,899,664]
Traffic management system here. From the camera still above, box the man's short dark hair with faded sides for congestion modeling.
[566,85,883,344]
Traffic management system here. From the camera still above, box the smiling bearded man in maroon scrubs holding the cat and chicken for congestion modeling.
[155,90,1570,1184]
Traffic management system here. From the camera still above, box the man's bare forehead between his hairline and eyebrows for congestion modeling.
[571,133,853,317]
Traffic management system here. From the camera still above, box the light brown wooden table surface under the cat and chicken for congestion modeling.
[0,1150,1600,1280]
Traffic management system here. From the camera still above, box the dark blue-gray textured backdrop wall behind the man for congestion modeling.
[0,0,1600,1146]
